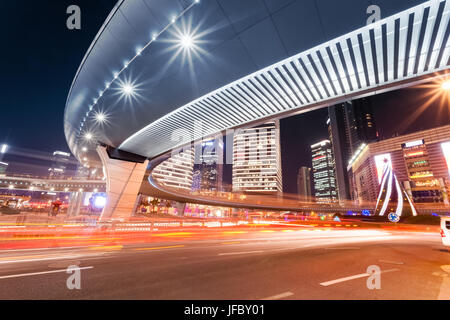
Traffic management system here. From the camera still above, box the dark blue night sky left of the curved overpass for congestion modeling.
[0,0,116,151]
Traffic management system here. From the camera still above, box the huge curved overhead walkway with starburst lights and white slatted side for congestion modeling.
[64,0,450,220]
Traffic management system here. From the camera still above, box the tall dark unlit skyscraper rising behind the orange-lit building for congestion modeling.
[327,98,378,200]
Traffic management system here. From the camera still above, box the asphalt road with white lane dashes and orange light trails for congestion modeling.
[0,229,450,300]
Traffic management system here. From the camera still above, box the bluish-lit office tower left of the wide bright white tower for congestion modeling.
[192,138,224,191]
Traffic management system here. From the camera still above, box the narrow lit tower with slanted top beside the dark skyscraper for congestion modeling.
[311,140,337,202]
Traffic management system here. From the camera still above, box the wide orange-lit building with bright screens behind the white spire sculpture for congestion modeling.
[347,125,450,204]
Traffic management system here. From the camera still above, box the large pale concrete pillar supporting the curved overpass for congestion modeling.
[97,146,148,221]
